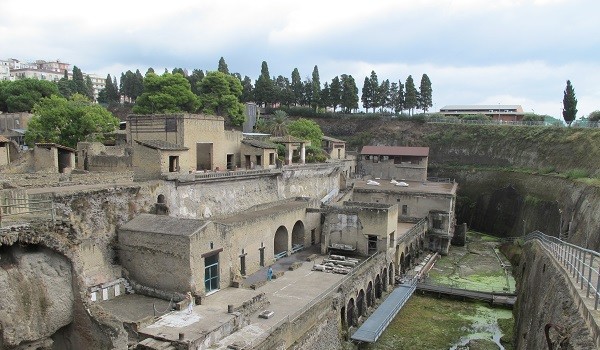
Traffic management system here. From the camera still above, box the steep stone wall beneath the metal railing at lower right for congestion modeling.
[514,241,600,350]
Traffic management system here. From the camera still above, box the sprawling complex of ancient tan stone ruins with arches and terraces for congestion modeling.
[0,114,457,349]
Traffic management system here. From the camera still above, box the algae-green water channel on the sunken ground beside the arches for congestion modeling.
[361,232,515,350]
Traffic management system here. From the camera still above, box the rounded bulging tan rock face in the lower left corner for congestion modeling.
[0,245,74,346]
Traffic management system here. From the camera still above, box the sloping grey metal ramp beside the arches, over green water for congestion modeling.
[351,279,417,343]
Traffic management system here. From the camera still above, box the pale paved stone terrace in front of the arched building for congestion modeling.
[102,247,345,349]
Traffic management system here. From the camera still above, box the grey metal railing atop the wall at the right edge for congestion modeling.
[524,231,600,310]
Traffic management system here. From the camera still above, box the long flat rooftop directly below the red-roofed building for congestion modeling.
[354,179,457,195]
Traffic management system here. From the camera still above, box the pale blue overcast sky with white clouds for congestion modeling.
[0,0,600,117]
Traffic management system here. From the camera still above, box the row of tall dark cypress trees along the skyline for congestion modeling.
[99,57,432,113]
